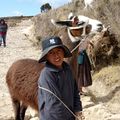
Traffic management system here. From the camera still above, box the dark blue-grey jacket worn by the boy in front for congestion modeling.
[38,62,82,120]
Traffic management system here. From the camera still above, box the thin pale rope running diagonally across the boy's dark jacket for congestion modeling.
[38,86,83,120]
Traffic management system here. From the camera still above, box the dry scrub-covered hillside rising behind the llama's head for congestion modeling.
[33,0,120,42]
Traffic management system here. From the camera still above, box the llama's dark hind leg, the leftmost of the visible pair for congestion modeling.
[12,98,21,120]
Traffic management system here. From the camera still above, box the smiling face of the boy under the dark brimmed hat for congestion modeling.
[46,48,64,68]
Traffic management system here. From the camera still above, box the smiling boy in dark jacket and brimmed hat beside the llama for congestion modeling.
[38,36,82,120]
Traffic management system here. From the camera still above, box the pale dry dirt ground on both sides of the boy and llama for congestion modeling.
[0,20,120,120]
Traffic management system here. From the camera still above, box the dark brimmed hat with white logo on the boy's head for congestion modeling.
[39,36,72,62]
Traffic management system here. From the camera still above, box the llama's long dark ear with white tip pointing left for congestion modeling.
[51,19,72,27]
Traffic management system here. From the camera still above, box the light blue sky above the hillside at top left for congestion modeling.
[0,0,71,17]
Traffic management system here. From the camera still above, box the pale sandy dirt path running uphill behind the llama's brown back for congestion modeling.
[0,21,40,120]
